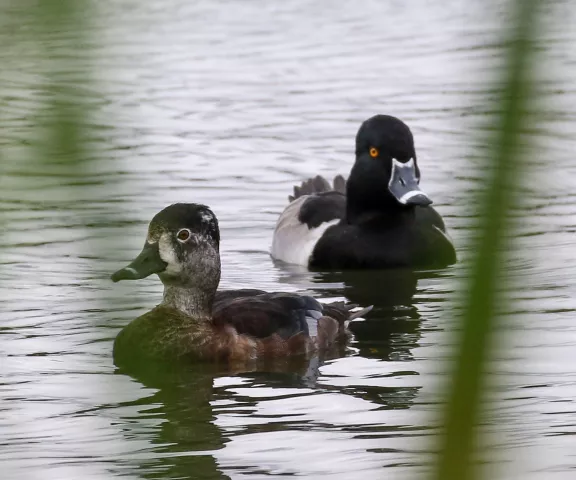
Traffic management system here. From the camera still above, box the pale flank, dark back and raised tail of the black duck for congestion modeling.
[271,175,346,266]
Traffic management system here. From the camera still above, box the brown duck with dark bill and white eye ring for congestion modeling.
[111,203,372,365]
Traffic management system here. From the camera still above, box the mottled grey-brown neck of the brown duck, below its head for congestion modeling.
[162,285,216,322]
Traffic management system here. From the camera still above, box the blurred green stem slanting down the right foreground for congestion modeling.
[433,0,537,480]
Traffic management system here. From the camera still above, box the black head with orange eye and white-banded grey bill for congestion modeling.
[347,115,432,222]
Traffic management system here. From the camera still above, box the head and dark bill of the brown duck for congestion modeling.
[112,203,220,285]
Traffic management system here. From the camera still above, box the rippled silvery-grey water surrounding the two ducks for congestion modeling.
[0,0,576,480]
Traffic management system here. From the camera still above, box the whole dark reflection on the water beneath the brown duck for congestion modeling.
[115,347,344,479]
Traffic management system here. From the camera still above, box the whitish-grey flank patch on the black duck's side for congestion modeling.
[270,195,340,266]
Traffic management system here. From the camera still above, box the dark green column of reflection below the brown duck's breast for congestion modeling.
[117,362,228,479]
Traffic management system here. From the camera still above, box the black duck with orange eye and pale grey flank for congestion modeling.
[271,115,456,270]
